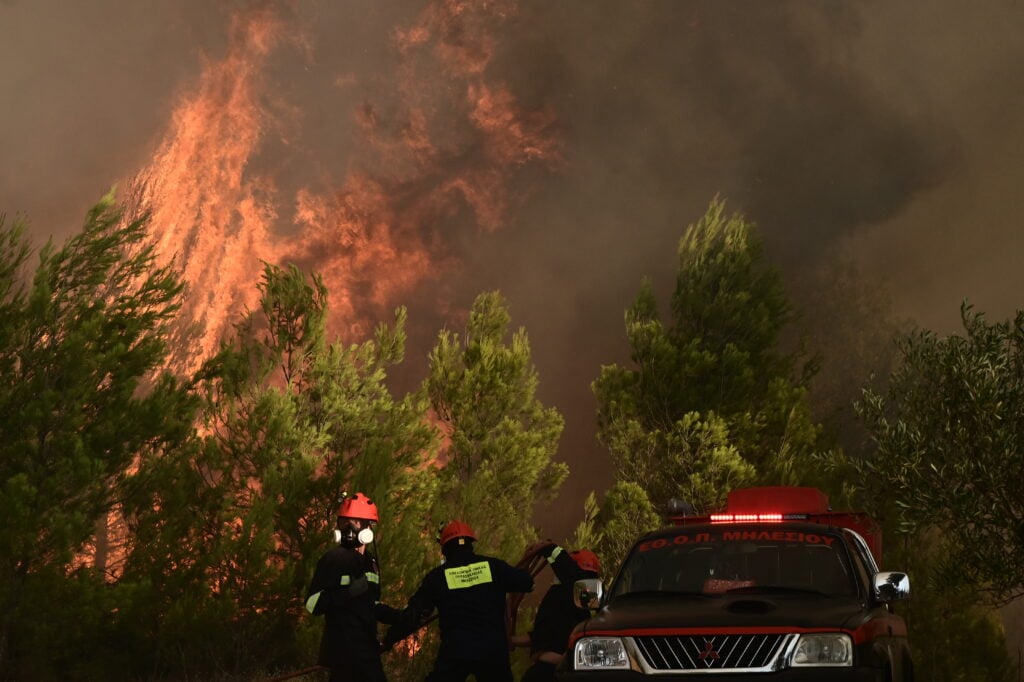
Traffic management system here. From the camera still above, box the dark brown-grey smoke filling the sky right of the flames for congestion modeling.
[467,0,1024,520]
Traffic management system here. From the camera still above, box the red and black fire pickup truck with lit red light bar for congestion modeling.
[557,486,913,682]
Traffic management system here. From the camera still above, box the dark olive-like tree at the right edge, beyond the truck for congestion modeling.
[858,304,1024,602]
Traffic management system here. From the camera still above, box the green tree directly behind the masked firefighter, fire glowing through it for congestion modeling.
[120,265,436,675]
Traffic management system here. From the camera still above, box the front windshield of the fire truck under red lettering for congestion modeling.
[610,528,857,598]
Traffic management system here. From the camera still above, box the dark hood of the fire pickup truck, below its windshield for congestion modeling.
[577,592,866,635]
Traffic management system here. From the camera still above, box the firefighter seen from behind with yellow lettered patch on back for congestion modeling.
[384,521,534,682]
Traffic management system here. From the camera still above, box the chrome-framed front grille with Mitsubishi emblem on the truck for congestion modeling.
[633,635,787,673]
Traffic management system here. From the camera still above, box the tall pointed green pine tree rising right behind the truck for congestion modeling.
[593,199,820,561]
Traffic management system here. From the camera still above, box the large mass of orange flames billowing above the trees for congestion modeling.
[123,0,560,369]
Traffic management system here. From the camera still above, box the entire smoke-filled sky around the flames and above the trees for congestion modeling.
[0,0,1024,532]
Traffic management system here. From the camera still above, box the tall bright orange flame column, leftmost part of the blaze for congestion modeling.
[132,10,283,366]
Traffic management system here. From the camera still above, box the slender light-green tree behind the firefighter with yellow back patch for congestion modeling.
[426,292,567,561]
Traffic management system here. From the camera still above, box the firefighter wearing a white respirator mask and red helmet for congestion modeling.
[306,493,397,682]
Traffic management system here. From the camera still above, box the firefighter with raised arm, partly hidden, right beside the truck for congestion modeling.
[513,540,601,682]
